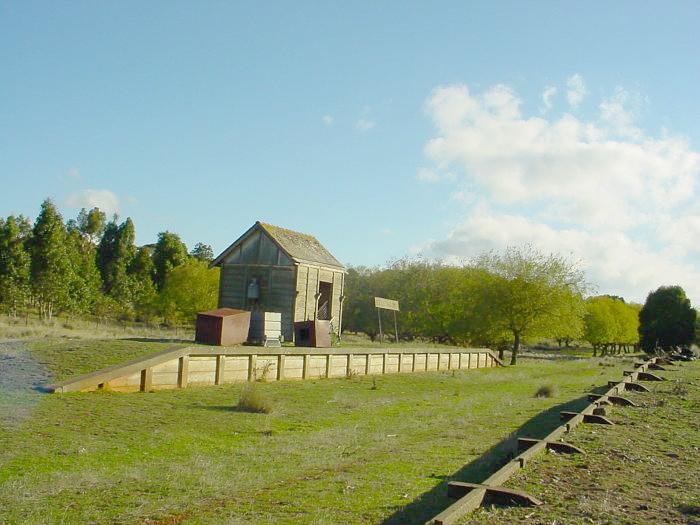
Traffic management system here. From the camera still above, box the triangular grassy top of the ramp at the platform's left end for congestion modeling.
[27,338,185,381]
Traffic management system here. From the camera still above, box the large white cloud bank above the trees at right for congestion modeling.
[424,85,700,301]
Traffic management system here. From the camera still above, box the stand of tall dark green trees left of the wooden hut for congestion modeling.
[0,199,219,324]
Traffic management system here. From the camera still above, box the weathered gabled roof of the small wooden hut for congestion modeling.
[211,221,345,270]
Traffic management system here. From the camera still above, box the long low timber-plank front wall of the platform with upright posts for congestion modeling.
[49,345,502,393]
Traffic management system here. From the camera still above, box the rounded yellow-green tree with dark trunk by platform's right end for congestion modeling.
[472,246,588,365]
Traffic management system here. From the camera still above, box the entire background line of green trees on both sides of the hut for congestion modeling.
[0,199,700,354]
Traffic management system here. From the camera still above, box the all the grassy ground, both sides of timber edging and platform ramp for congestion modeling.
[0,337,700,525]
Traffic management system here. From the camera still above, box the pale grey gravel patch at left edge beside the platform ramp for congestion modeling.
[0,340,49,426]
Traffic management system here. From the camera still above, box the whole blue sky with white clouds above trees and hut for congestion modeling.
[0,0,700,304]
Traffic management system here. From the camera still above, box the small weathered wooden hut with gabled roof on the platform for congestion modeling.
[211,221,346,341]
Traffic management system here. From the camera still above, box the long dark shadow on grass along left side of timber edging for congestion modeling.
[382,396,592,525]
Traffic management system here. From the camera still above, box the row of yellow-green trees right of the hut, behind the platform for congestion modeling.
[343,247,697,364]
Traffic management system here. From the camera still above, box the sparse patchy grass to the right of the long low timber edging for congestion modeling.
[461,362,700,525]
